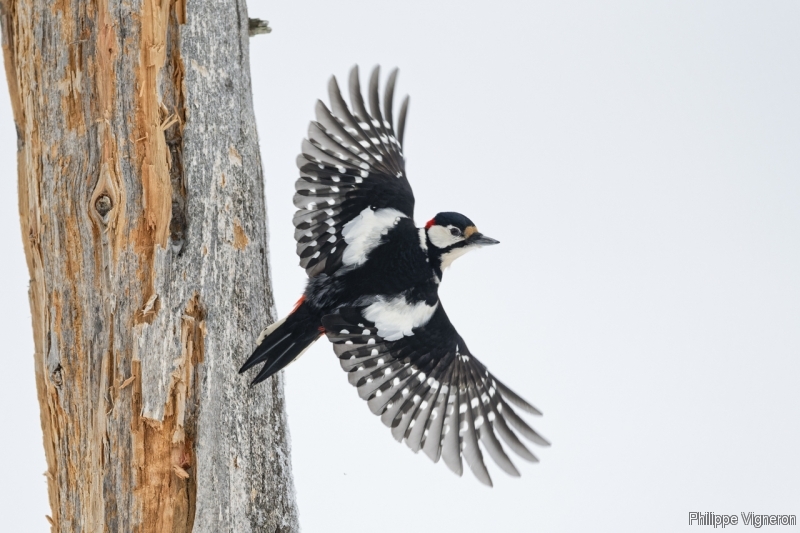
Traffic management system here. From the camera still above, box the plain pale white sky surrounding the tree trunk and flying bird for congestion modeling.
[0,0,800,533]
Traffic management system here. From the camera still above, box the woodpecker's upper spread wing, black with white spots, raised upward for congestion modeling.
[293,67,414,277]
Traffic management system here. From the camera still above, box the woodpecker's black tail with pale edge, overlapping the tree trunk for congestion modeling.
[239,298,322,384]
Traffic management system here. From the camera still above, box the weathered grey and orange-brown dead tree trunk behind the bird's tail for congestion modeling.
[0,0,299,533]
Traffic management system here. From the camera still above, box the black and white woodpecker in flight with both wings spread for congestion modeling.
[240,66,549,486]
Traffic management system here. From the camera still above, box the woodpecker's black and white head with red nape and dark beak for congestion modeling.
[425,212,500,278]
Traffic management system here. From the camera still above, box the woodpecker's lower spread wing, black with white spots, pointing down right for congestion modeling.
[322,302,549,486]
